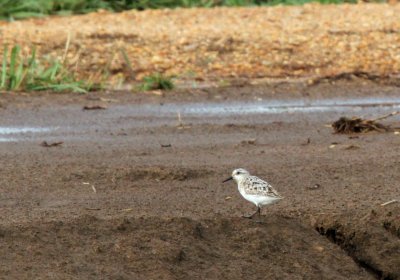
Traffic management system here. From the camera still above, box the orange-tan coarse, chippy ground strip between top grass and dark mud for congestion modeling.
[0,4,400,84]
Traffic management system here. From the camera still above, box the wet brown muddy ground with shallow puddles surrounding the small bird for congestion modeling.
[0,79,400,279]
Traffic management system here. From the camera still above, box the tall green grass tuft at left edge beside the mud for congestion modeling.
[0,46,94,93]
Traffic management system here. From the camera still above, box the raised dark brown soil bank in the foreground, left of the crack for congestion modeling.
[0,215,370,279]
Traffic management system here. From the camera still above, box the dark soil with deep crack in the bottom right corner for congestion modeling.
[315,203,400,280]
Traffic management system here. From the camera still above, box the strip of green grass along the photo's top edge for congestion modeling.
[0,0,372,20]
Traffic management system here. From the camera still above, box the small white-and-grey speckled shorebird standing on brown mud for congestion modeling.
[222,168,283,219]
